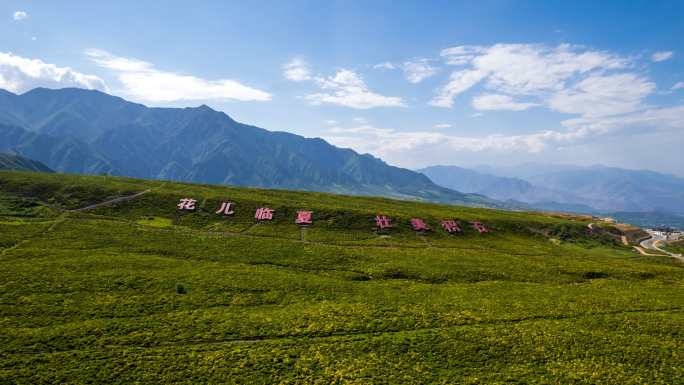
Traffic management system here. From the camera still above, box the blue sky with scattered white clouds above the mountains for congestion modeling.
[0,0,684,175]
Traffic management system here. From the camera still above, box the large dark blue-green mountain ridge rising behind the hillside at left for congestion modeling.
[0,88,499,206]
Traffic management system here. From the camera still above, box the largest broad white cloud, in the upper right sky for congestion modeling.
[430,44,655,116]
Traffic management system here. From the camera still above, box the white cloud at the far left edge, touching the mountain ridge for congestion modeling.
[0,52,107,93]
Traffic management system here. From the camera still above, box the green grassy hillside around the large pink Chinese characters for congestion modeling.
[0,172,684,384]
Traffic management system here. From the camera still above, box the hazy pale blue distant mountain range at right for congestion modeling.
[418,163,684,215]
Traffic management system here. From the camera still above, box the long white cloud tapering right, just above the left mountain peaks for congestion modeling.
[85,49,271,102]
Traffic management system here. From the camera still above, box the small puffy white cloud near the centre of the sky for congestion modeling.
[305,69,405,109]
